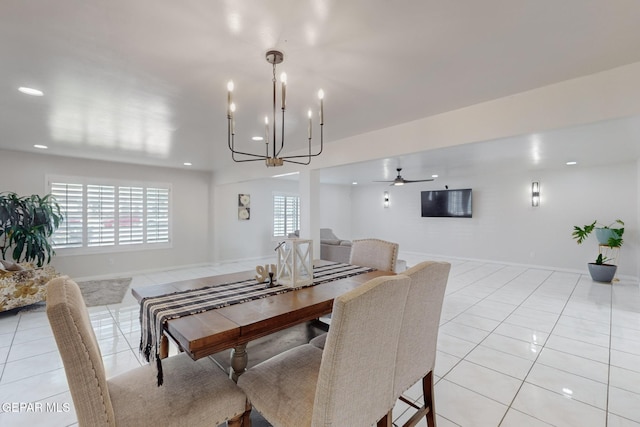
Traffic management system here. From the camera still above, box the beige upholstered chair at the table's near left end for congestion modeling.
[47,277,246,427]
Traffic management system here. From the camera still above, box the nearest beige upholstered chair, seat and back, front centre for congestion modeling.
[238,275,410,427]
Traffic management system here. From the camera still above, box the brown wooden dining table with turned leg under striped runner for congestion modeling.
[131,260,394,381]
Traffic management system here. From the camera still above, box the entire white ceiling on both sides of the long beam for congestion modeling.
[0,0,640,183]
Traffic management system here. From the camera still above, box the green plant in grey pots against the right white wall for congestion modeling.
[571,219,624,283]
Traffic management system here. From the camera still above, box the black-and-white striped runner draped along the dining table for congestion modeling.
[140,263,374,386]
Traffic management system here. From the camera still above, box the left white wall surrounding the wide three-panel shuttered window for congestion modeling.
[0,150,211,278]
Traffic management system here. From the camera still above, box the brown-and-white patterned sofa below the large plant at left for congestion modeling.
[0,263,59,312]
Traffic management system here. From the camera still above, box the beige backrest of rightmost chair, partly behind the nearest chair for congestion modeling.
[396,261,451,397]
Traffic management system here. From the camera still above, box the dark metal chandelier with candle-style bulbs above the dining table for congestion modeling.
[227,50,324,167]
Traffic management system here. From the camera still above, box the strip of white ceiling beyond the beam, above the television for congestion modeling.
[320,117,640,185]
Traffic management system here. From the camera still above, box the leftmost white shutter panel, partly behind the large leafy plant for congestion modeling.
[51,182,84,248]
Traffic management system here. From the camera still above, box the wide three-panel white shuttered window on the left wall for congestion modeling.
[49,177,170,250]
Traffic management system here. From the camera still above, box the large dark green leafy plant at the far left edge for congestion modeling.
[0,192,63,267]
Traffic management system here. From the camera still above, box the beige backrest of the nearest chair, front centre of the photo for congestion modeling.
[312,275,411,426]
